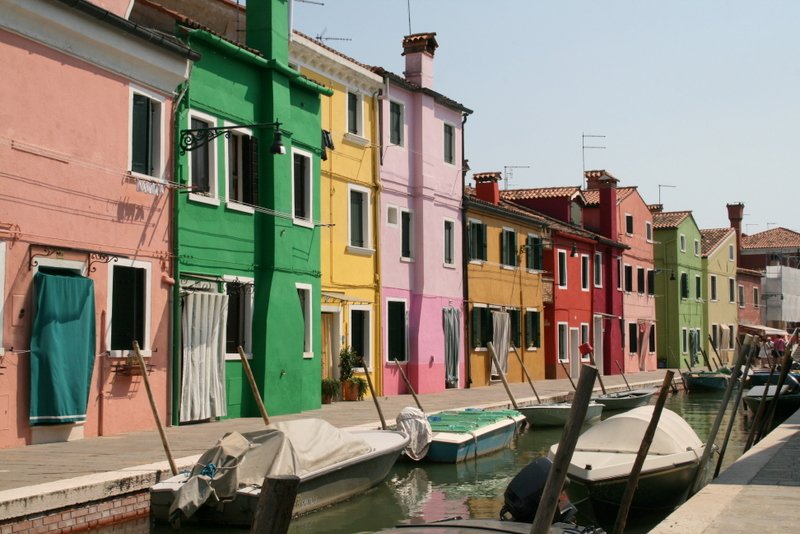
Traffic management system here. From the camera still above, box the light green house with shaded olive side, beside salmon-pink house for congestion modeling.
[650,205,707,369]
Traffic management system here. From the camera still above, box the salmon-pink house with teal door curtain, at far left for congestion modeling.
[0,0,194,447]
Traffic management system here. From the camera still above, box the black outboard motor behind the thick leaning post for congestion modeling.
[500,458,578,523]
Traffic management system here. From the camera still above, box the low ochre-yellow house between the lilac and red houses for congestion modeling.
[464,172,552,387]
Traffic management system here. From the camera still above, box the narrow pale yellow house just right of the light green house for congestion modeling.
[700,228,739,364]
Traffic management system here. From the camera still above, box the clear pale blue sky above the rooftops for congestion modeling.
[293,0,800,234]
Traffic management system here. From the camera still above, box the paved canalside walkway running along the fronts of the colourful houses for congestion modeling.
[0,370,664,521]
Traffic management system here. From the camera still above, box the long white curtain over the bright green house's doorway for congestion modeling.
[180,292,228,422]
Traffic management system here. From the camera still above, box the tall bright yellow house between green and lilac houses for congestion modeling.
[289,32,383,392]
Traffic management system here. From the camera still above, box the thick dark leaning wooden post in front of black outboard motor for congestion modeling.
[531,365,598,534]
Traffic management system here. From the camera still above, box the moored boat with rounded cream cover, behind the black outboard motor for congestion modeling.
[549,406,705,510]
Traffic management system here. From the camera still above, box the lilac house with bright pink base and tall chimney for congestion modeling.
[375,33,471,395]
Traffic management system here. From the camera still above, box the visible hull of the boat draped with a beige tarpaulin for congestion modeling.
[150,430,408,526]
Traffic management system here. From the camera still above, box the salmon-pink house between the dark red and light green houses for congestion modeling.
[584,170,656,373]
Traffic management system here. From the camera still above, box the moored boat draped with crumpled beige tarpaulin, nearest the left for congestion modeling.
[150,419,408,525]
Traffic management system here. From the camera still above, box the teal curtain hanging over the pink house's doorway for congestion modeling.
[30,268,95,425]
